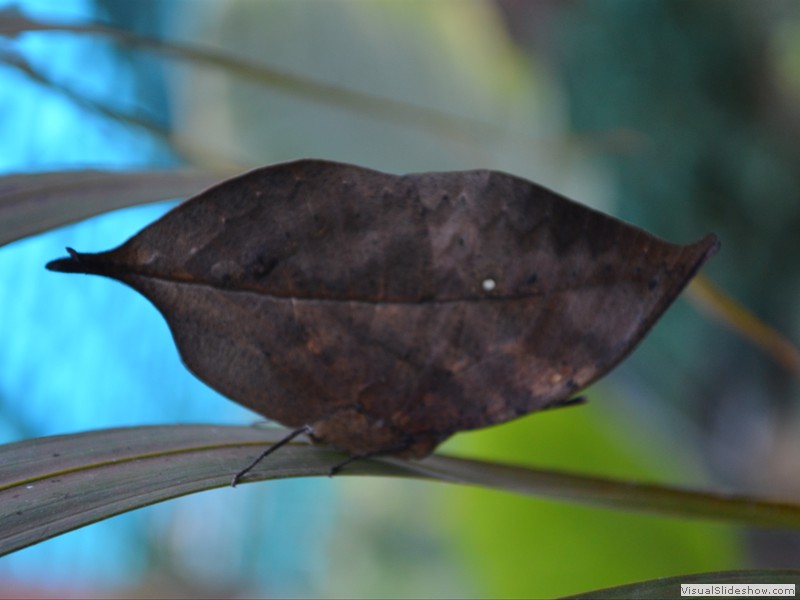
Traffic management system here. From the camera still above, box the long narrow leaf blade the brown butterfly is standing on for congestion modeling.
[0,425,800,554]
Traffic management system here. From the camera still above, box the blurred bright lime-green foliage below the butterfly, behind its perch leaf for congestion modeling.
[441,393,741,598]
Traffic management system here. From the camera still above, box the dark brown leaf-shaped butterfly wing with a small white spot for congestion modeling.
[45,161,717,456]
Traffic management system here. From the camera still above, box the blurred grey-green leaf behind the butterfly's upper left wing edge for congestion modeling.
[0,169,233,246]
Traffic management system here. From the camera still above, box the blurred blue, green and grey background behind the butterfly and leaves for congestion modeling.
[0,0,800,598]
